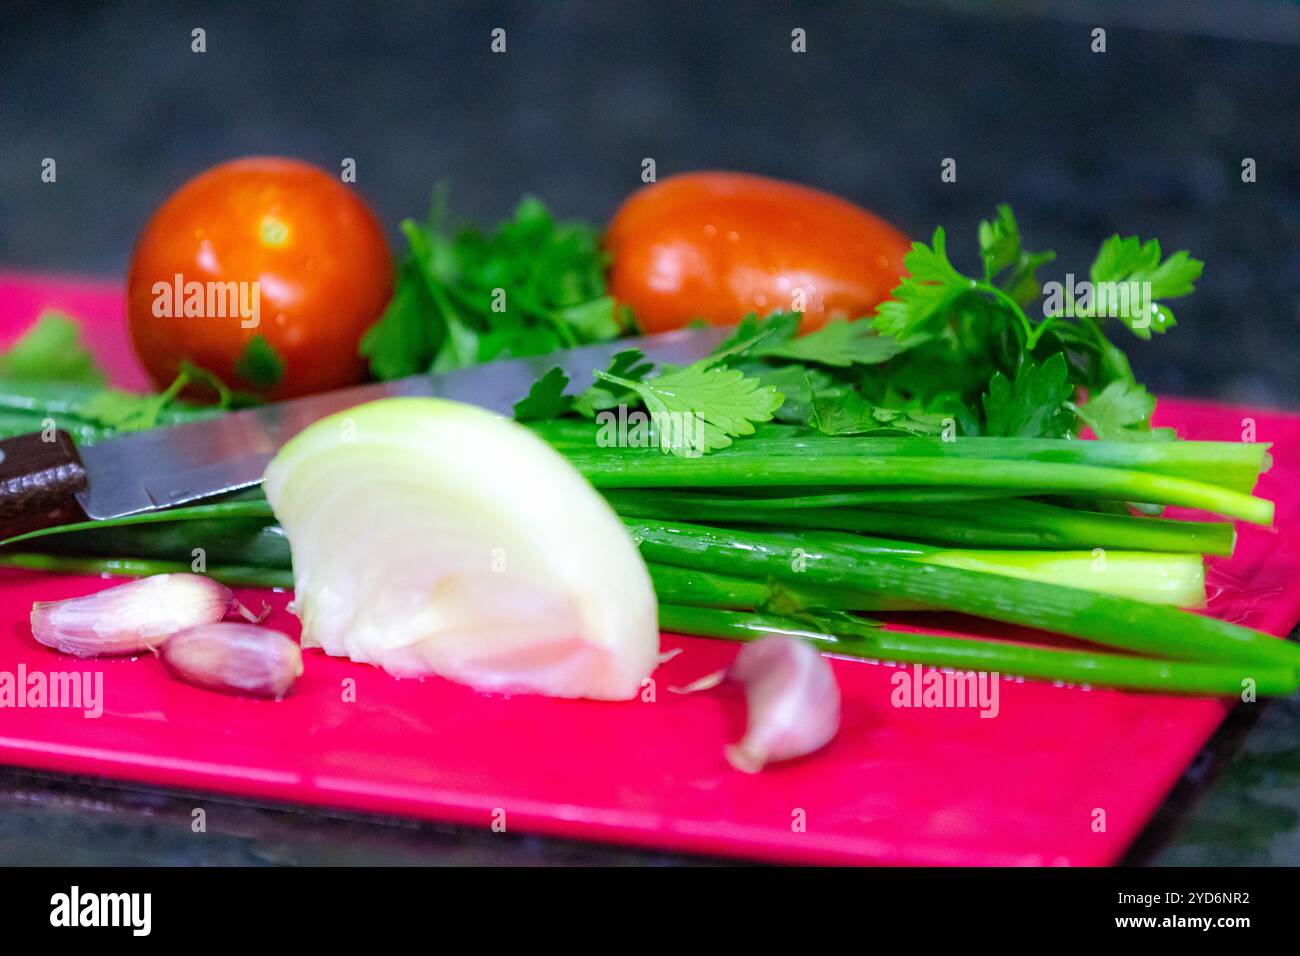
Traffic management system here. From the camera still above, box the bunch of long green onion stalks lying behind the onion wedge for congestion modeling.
[0,431,1279,693]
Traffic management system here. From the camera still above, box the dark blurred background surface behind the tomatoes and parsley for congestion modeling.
[0,0,1300,407]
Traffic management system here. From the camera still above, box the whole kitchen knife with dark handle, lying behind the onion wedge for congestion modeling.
[0,328,731,538]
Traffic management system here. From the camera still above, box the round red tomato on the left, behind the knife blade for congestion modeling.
[126,157,393,398]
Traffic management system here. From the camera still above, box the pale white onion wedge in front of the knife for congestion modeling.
[265,398,659,700]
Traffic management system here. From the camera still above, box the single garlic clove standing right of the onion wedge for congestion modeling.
[727,635,840,774]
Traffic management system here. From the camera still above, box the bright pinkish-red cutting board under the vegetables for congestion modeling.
[0,274,1300,865]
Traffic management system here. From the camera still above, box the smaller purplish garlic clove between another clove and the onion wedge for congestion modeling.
[159,622,303,700]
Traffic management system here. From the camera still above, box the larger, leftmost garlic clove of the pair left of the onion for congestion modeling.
[31,574,235,657]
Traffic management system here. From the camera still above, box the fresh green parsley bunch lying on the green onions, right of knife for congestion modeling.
[516,199,1201,450]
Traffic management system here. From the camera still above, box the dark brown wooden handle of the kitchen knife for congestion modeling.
[0,432,86,540]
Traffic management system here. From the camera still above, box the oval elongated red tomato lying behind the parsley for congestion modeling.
[606,173,910,332]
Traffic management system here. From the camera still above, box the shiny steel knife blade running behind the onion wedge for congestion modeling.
[65,328,731,519]
